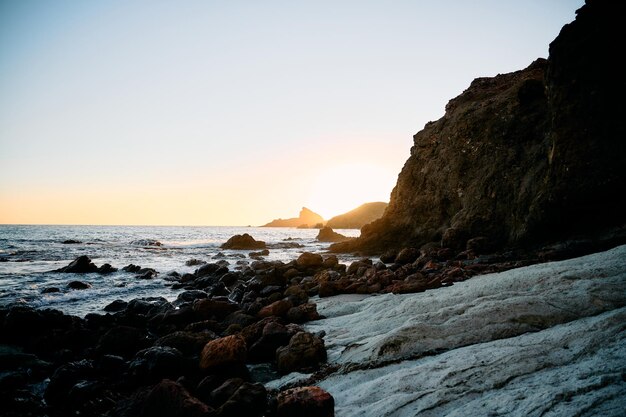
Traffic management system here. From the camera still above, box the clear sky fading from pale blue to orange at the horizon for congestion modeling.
[0,0,583,225]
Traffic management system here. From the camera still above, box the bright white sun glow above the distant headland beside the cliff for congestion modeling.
[305,164,396,220]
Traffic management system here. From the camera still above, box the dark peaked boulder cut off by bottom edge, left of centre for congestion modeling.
[138,379,213,417]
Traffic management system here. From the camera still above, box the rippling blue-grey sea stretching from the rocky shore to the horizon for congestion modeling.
[0,225,360,317]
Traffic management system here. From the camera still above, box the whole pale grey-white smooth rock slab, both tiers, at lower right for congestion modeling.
[307,246,626,417]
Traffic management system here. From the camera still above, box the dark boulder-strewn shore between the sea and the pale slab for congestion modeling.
[0,228,624,416]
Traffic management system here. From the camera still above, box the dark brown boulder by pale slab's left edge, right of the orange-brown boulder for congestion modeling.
[276,332,326,374]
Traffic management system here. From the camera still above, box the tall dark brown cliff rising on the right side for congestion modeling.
[332,0,626,252]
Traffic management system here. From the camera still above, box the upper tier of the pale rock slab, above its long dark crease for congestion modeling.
[307,246,626,364]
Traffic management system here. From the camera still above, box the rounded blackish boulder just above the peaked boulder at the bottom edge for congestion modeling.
[129,346,186,382]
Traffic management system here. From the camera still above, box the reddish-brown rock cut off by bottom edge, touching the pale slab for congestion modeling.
[276,387,335,417]
